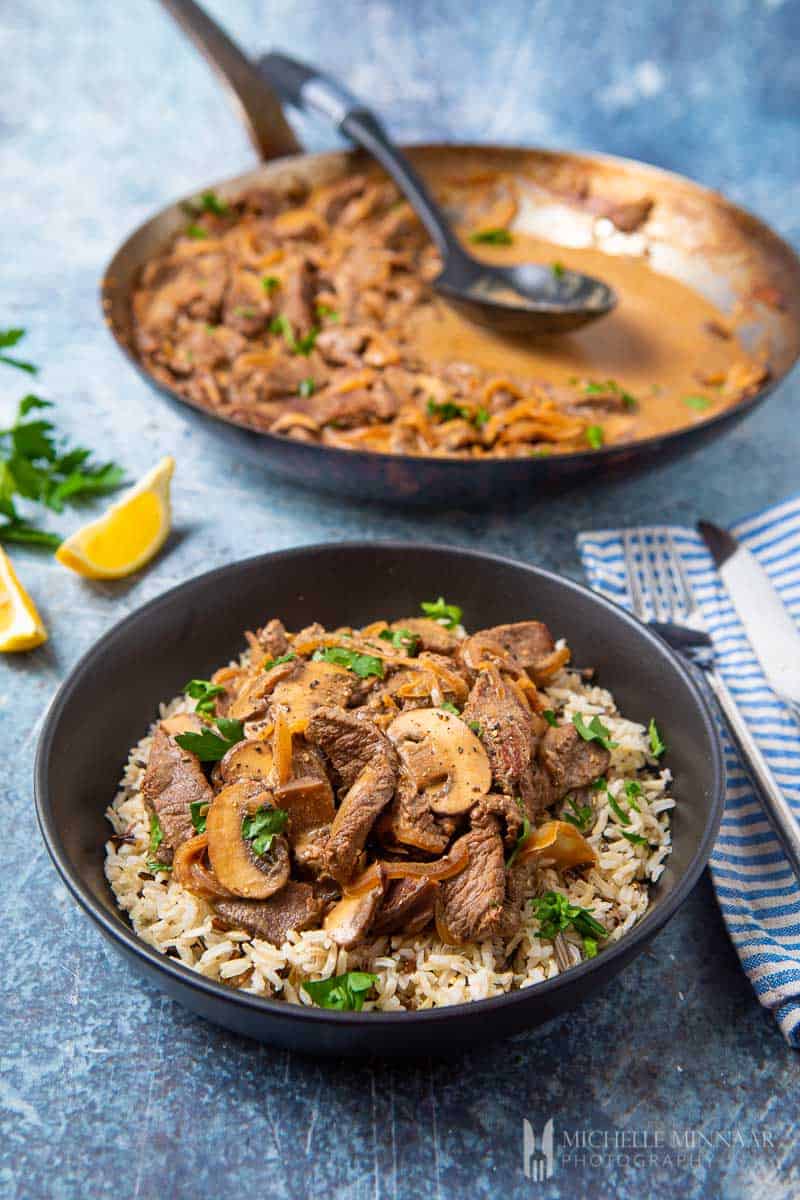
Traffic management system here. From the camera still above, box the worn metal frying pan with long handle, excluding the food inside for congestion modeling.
[102,0,800,506]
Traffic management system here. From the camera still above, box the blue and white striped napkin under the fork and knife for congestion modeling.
[577,496,800,1048]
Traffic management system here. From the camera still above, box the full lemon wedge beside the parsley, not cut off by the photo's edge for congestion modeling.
[55,456,175,580]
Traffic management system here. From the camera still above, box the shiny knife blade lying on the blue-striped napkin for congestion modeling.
[697,521,800,712]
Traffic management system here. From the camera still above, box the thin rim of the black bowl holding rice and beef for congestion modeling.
[34,540,726,1028]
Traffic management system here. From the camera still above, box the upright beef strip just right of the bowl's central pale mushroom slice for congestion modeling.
[462,666,536,800]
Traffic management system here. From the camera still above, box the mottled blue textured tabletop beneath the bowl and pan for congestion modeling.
[0,0,800,1200]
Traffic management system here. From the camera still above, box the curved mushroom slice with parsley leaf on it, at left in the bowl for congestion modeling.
[205,780,290,900]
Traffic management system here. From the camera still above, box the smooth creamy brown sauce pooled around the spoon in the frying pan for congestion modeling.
[411,234,759,442]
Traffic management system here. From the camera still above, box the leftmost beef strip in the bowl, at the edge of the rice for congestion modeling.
[142,722,213,863]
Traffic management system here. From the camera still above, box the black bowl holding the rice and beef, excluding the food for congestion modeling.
[36,542,724,1055]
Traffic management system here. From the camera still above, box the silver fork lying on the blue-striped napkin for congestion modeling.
[622,529,800,878]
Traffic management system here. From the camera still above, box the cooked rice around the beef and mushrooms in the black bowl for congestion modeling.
[106,672,675,1012]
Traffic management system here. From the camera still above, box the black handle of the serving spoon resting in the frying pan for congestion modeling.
[258,53,463,258]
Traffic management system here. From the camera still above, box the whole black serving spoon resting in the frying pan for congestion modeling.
[258,53,616,334]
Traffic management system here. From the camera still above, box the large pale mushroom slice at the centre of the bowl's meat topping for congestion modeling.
[386,708,492,815]
